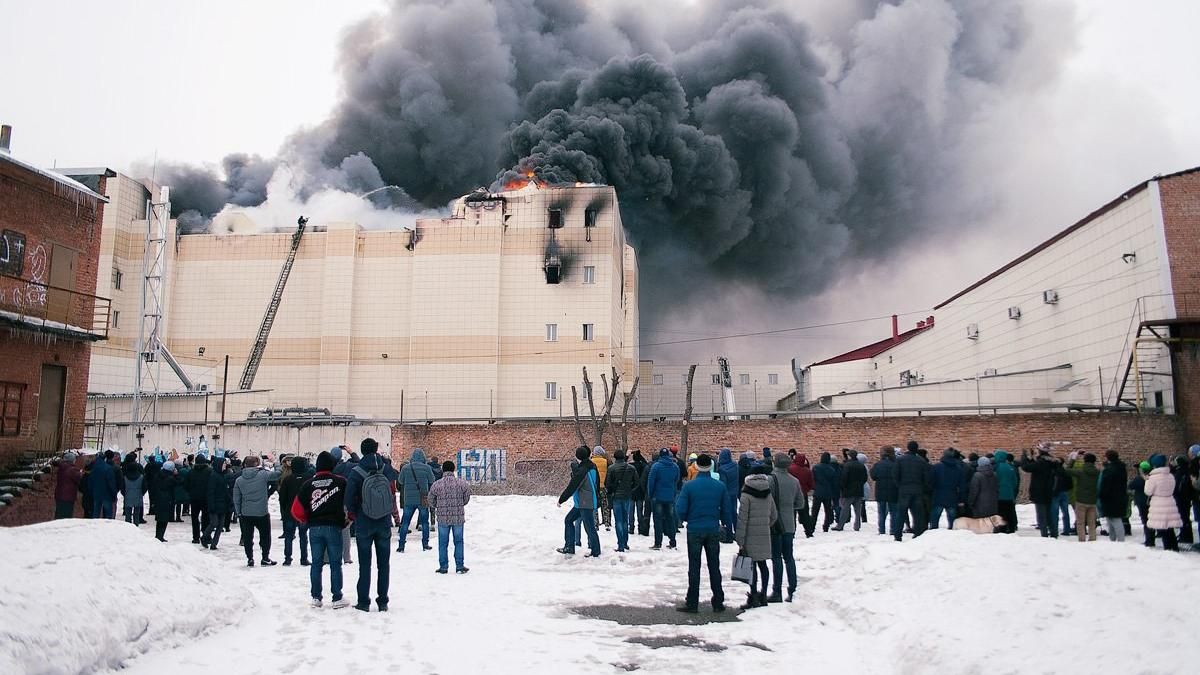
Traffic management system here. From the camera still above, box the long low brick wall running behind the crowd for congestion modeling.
[391,413,1186,487]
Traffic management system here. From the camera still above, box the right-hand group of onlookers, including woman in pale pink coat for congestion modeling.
[558,441,1200,611]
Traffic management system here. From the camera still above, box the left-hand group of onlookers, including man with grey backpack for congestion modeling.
[55,438,470,611]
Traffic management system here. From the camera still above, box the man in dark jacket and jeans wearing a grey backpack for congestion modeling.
[346,438,400,611]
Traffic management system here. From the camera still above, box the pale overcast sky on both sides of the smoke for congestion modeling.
[0,0,1200,360]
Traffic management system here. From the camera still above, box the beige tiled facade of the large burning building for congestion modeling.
[89,181,638,422]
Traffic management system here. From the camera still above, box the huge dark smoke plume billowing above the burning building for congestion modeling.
[164,0,1057,325]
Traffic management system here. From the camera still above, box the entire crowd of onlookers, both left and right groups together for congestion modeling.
[55,438,1200,611]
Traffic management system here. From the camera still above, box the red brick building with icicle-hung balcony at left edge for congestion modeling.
[0,136,109,467]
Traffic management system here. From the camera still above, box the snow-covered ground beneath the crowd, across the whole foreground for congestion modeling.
[0,496,1200,675]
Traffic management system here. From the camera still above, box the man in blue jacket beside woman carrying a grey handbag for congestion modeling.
[676,450,720,614]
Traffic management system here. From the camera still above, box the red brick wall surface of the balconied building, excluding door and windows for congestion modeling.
[0,161,104,467]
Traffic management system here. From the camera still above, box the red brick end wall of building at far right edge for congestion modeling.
[1158,172,1200,440]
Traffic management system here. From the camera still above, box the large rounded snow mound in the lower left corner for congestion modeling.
[0,520,252,674]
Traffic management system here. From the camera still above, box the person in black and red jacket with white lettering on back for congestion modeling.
[292,452,349,609]
